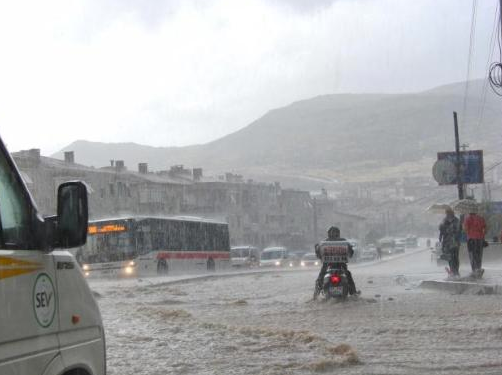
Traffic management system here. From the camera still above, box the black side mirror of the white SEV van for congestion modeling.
[57,181,88,248]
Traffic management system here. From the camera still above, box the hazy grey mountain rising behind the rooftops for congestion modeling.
[53,80,502,185]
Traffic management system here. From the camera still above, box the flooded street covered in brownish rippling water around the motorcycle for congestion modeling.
[91,251,502,375]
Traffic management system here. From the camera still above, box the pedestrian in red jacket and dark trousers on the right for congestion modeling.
[463,208,486,278]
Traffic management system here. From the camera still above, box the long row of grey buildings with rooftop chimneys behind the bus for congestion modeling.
[12,149,320,249]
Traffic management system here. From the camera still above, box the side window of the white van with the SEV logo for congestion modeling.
[0,153,33,248]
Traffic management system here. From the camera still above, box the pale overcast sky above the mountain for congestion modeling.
[0,0,498,154]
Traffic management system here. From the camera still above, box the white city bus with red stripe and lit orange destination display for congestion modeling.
[76,217,230,277]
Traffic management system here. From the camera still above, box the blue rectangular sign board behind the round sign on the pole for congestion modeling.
[438,150,484,184]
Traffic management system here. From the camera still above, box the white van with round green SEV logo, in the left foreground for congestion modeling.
[0,139,106,375]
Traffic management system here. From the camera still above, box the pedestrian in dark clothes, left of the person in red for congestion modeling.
[439,207,462,277]
